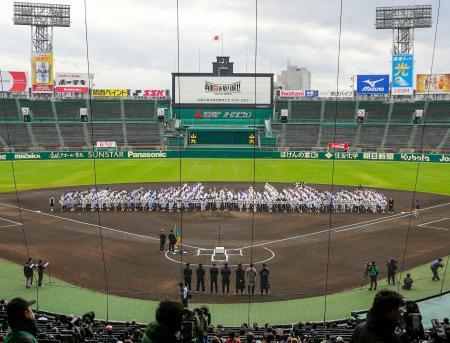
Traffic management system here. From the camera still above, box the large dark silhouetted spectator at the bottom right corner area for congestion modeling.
[351,290,404,343]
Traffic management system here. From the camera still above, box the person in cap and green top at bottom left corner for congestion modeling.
[5,298,38,343]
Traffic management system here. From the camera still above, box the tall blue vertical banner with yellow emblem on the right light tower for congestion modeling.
[392,55,414,95]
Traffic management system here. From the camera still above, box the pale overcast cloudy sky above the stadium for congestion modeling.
[0,0,450,90]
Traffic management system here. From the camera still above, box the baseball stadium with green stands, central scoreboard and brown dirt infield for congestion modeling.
[0,1,450,342]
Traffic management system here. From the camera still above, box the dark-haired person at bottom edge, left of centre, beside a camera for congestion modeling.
[142,300,183,343]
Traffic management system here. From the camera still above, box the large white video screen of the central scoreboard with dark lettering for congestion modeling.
[173,75,272,105]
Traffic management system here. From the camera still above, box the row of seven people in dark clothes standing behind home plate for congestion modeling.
[181,263,270,295]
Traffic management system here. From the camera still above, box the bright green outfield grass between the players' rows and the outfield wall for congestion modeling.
[0,159,450,194]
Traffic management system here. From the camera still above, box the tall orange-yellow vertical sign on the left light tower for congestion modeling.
[31,52,53,93]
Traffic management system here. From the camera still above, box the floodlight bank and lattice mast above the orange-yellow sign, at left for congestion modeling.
[14,2,70,53]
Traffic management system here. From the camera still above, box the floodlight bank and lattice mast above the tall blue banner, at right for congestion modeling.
[375,5,433,55]
